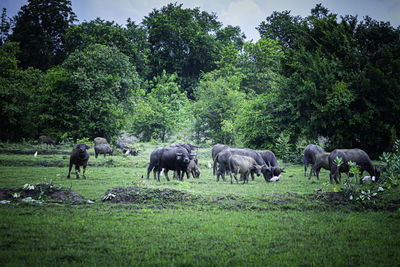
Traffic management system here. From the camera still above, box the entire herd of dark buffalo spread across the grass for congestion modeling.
[39,136,380,184]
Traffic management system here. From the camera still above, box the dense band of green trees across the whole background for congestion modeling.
[0,0,400,156]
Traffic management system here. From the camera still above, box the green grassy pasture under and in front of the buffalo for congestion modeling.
[0,143,400,266]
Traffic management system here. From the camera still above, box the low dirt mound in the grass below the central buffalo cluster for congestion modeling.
[103,186,197,205]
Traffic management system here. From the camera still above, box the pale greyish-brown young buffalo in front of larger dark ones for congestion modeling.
[229,155,262,184]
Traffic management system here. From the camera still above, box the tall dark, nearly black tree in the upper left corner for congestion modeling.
[10,0,76,70]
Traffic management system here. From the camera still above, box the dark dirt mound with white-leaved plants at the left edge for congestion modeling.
[0,184,85,204]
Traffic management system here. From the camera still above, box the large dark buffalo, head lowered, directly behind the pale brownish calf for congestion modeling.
[214,148,273,182]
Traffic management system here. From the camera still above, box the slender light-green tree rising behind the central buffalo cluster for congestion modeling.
[129,71,188,142]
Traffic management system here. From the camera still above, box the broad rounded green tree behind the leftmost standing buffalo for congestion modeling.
[41,45,140,140]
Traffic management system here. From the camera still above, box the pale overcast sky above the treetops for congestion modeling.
[0,0,400,41]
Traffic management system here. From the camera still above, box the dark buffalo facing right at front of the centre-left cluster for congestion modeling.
[157,146,194,181]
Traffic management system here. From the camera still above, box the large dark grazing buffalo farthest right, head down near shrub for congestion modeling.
[328,148,380,184]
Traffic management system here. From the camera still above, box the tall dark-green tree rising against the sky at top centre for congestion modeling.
[142,4,222,95]
